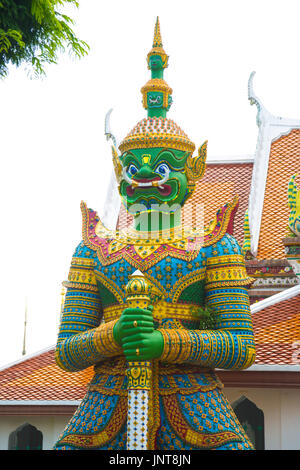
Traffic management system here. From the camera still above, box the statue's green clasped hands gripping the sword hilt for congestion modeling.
[114,306,164,362]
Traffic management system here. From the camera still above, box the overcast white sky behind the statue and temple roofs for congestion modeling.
[0,0,300,365]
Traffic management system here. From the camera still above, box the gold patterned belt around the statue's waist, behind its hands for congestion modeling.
[103,300,199,323]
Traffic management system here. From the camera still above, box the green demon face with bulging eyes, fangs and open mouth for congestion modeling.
[120,148,188,213]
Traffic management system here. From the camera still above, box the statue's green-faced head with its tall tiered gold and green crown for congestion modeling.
[113,18,207,210]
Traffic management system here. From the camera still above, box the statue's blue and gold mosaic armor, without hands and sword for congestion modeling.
[55,201,255,450]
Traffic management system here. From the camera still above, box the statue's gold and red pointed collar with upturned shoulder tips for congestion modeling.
[81,197,238,269]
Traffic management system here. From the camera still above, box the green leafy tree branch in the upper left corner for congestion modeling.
[0,0,89,77]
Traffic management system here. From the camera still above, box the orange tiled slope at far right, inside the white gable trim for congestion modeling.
[257,129,300,259]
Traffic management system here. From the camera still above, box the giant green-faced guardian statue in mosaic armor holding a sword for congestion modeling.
[55,19,255,450]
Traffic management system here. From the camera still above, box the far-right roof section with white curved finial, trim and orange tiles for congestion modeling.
[248,72,300,259]
